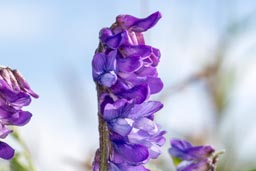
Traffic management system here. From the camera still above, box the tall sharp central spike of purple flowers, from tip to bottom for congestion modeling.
[92,12,165,171]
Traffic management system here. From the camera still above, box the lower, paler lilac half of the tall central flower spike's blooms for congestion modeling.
[97,94,165,169]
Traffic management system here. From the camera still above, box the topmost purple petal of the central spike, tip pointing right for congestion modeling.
[116,12,161,32]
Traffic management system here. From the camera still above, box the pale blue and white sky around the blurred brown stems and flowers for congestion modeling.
[0,0,256,171]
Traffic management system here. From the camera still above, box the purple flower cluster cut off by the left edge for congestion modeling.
[0,66,38,159]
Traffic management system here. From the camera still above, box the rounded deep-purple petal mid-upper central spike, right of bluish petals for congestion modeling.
[117,56,143,72]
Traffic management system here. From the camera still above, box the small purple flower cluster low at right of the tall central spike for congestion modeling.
[169,139,225,171]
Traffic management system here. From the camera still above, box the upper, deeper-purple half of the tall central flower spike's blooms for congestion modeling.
[92,12,163,100]
